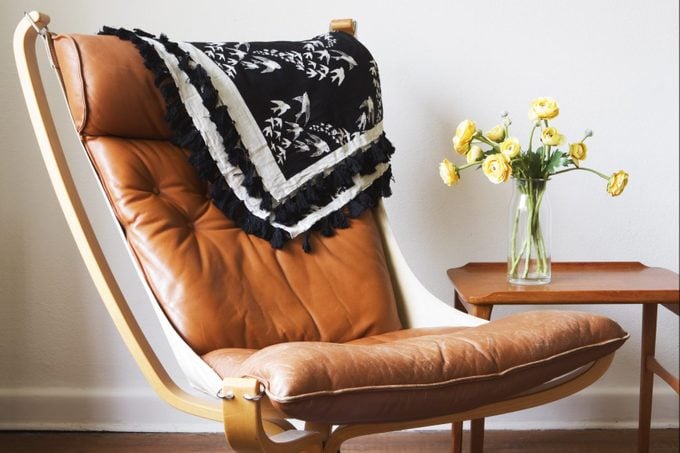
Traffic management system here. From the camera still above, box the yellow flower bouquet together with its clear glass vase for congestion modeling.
[439,97,628,284]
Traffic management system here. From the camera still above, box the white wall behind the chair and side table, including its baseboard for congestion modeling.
[0,0,678,430]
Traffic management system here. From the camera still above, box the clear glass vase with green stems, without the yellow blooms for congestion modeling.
[508,179,552,285]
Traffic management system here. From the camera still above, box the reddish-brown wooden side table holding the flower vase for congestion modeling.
[447,262,680,453]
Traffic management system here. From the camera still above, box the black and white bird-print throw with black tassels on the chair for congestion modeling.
[101,27,394,251]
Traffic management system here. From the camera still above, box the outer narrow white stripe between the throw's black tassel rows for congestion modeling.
[142,37,389,238]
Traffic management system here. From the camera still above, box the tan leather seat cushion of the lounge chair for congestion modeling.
[204,311,628,424]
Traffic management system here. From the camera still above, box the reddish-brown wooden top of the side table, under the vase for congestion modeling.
[447,262,680,311]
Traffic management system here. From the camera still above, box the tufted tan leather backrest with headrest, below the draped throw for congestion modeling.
[54,35,401,354]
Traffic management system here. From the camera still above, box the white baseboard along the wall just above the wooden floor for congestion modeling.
[0,385,678,432]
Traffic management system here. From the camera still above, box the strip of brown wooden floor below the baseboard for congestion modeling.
[0,429,680,453]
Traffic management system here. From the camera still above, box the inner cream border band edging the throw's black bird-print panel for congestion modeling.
[178,42,383,200]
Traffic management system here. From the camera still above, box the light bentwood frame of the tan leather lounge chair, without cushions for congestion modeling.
[14,11,614,453]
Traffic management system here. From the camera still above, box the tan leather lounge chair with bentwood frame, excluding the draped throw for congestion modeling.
[15,12,627,452]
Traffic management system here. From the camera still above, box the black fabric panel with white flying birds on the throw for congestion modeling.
[193,32,382,177]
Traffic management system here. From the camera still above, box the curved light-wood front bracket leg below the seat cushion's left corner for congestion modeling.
[222,378,322,453]
